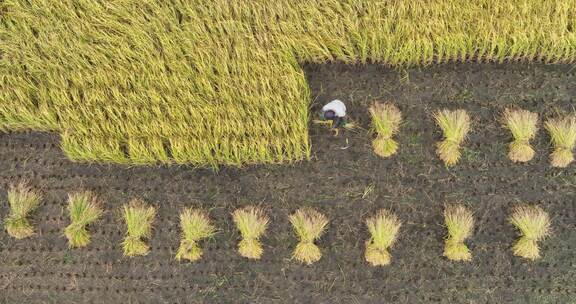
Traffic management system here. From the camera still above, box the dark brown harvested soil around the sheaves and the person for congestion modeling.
[0,64,576,304]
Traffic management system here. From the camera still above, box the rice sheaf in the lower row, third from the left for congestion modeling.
[122,199,156,257]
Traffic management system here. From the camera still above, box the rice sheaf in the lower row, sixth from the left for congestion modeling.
[290,208,328,265]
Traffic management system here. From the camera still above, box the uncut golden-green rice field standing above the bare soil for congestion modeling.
[0,0,576,166]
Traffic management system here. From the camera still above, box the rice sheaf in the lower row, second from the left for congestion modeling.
[64,191,103,248]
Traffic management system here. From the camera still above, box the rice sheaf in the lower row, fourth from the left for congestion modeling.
[176,208,216,262]
